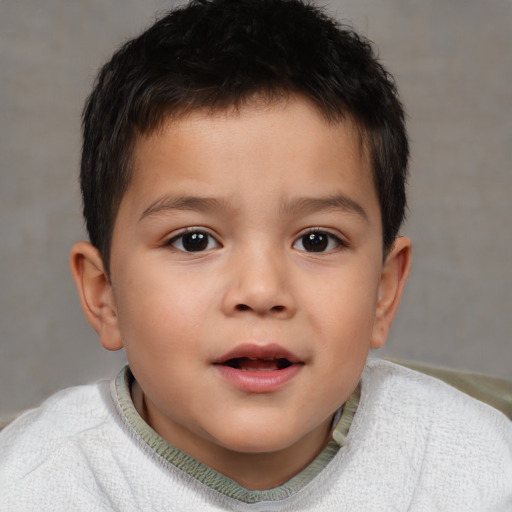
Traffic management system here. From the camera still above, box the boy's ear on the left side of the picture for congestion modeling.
[70,242,123,350]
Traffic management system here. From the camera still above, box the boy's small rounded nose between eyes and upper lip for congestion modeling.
[222,246,296,319]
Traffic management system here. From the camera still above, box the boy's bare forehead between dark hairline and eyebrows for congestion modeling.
[126,98,377,222]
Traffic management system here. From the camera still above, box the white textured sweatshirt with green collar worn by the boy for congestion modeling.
[0,361,512,512]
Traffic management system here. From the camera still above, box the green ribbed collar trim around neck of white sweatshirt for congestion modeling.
[115,366,360,503]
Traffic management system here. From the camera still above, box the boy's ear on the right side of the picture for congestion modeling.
[370,237,411,348]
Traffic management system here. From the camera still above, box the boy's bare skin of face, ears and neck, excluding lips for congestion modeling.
[71,98,410,489]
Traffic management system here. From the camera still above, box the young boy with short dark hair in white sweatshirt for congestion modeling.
[0,0,512,512]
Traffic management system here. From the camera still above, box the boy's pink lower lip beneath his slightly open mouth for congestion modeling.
[215,364,303,393]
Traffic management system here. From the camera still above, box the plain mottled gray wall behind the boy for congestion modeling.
[0,0,512,417]
